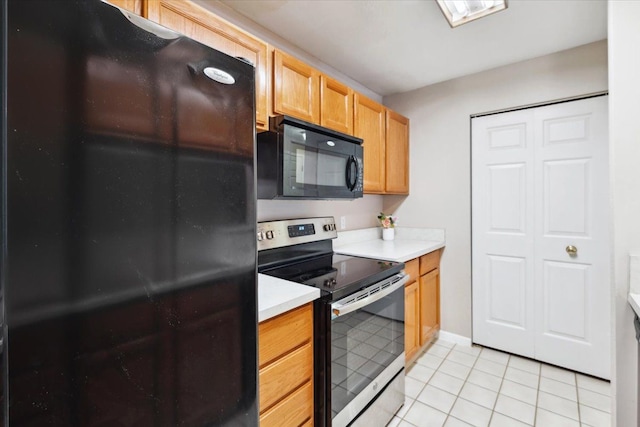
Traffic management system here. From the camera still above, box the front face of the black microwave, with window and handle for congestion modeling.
[282,125,363,199]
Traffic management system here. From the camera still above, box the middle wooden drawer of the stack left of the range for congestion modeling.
[260,343,313,411]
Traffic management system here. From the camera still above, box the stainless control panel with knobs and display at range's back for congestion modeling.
[257,216,338,251]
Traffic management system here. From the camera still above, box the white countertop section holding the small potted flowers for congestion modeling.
[333,227,445,262]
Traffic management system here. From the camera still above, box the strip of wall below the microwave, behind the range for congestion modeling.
[258,195,382,230]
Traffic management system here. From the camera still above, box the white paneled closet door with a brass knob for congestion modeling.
[472,97,610,378]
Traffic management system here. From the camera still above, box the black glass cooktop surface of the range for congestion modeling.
[258,253,404,301]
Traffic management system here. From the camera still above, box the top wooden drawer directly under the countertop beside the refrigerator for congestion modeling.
[258,303,313,368]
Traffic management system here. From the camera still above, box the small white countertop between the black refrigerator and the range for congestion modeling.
[258,273,320,322]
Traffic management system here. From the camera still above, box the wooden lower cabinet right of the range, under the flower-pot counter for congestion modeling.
[404,249,441,362]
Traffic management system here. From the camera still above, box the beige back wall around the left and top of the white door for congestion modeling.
[383,41,608,337]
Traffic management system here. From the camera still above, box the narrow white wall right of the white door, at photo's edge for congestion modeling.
[609,1,640,427]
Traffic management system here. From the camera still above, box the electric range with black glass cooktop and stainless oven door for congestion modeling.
[258,217,408,427]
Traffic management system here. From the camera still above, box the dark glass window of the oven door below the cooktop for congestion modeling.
[331,287,404,417]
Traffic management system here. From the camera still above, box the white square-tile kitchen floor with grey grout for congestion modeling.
[388,340,611,427]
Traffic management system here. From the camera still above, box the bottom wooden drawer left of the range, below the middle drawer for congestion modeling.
[260,382,313,427]
